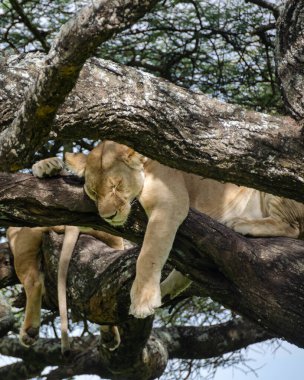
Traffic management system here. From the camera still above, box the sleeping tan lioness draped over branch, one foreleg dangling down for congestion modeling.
[45,141,304,318]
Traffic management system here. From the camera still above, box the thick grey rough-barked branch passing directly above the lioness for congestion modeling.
[0,56,304,201]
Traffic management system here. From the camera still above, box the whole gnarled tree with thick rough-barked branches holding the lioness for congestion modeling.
[0,0,304,379]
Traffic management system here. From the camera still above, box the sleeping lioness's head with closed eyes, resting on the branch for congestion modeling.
[65,141,146,226]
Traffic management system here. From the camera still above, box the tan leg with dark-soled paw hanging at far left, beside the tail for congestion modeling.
[7,227,44,346]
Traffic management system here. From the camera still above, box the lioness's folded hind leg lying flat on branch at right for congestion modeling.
[227,217,300,238]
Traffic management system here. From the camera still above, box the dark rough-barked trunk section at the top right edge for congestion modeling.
[276,0,304,120]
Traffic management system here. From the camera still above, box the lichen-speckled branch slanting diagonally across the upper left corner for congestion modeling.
[0,0,157,170]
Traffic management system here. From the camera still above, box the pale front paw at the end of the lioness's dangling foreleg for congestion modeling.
[129,279,161,318]
